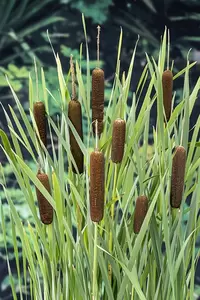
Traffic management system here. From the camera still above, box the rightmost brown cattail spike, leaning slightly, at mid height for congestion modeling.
[170,146,186,208]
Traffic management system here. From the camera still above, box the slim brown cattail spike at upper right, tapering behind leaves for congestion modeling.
[162,70,173,122]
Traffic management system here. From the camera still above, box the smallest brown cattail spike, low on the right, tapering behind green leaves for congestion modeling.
[133,196,148,234]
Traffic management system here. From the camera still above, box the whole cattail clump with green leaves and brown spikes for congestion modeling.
[0,26,200,300]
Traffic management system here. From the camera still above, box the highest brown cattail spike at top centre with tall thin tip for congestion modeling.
[92,68,104,136]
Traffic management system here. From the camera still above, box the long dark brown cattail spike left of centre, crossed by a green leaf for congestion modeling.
[68,100,83,174]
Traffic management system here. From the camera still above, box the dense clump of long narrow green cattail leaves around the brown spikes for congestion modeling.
[0,18,200,300]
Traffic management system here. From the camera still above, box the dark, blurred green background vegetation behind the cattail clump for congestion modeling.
[0,0,200,299]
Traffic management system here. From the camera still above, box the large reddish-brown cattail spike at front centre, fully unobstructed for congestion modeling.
[90,150,105,222]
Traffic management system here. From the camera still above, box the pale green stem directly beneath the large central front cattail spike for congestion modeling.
[92,223,98,300]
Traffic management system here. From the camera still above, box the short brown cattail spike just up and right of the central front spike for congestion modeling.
[111,119,126,163]
